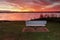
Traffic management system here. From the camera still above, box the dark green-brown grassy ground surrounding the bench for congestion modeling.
[0,22,60,40]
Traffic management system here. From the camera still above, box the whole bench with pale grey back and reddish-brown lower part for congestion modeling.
[23,20,48,32]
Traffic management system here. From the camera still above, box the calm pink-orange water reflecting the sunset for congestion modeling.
[0,13,60,21]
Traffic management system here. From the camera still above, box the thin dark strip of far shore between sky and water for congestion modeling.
[0,11,60,13]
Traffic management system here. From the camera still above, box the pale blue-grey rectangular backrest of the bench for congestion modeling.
[26,21,47,26]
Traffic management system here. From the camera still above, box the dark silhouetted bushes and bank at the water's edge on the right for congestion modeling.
[32,15,60,23]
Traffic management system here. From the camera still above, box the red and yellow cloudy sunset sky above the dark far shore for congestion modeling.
[0,0,60,12]
